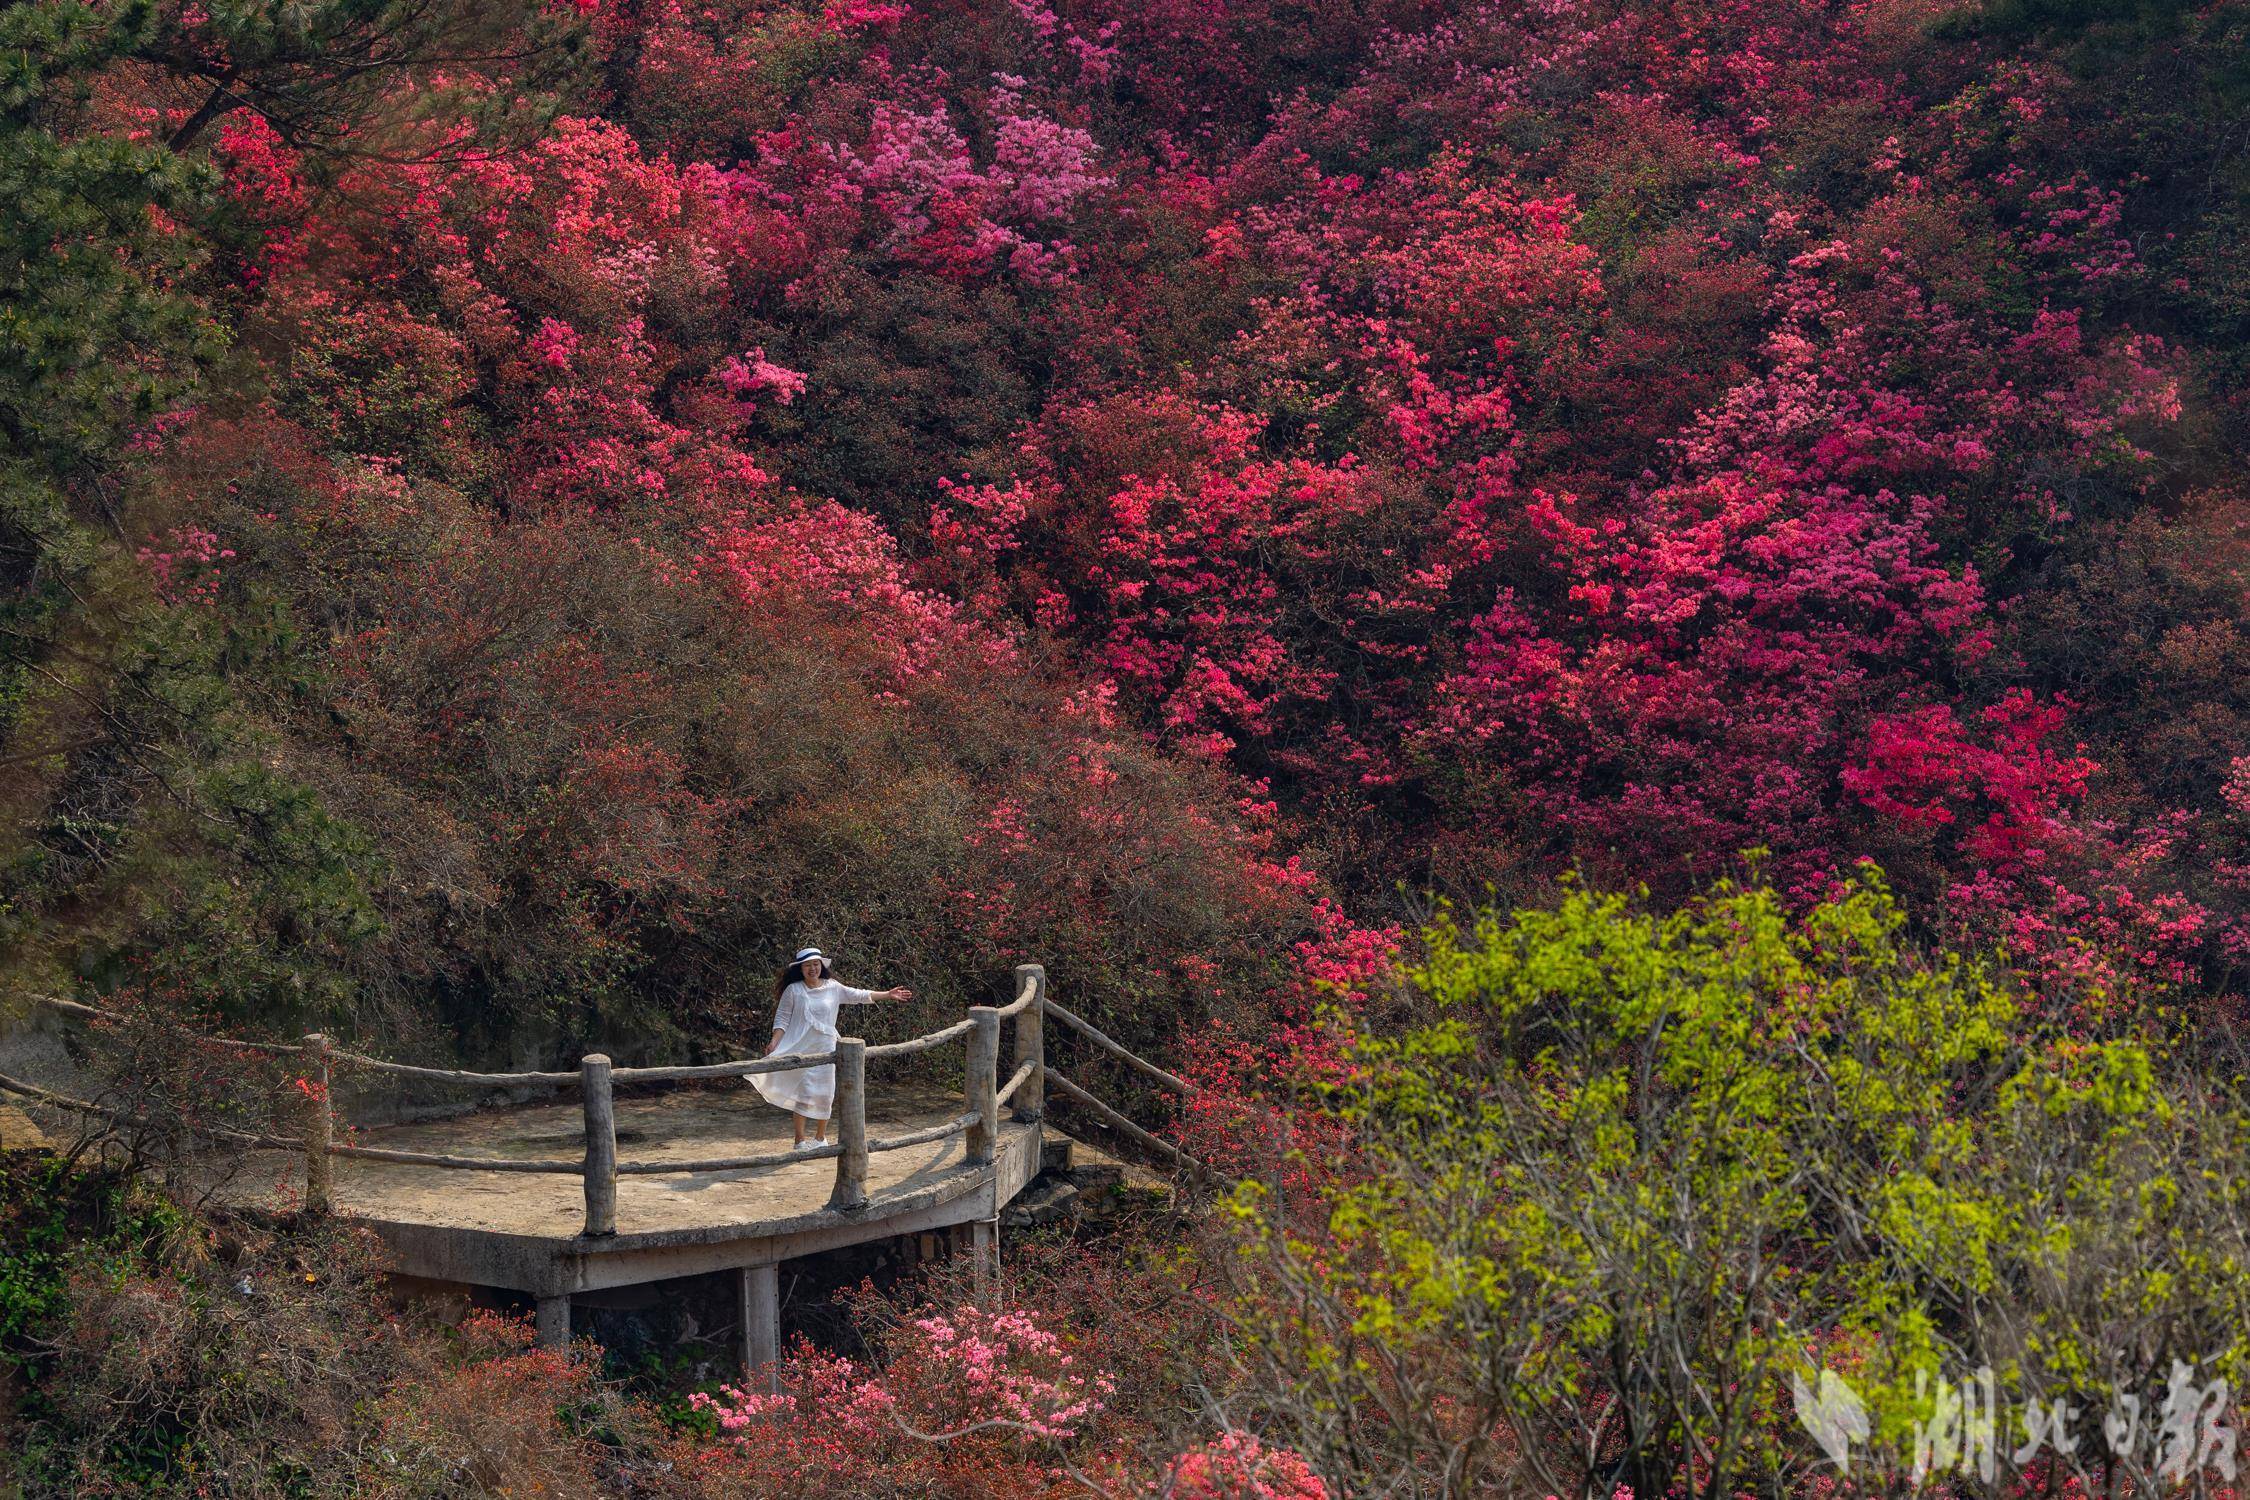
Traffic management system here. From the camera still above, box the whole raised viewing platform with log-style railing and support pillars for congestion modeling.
[0,963,1202,1370]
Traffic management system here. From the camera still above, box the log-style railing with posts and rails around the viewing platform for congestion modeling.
[0,963,1208,1237]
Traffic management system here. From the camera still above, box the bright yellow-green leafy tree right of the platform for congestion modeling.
[1235,870,2250,1496]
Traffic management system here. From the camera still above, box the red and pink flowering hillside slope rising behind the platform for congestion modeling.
[0,0,2250,1046]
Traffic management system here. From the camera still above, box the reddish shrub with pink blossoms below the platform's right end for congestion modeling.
[666,1210,1337,1500]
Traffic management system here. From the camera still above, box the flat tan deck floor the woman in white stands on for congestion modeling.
[202,1084,1037,1241]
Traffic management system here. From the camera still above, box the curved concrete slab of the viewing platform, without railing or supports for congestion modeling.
[214,1086,1040,1302]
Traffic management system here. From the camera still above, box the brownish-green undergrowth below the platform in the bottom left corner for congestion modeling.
[0,1151,693,1498]
